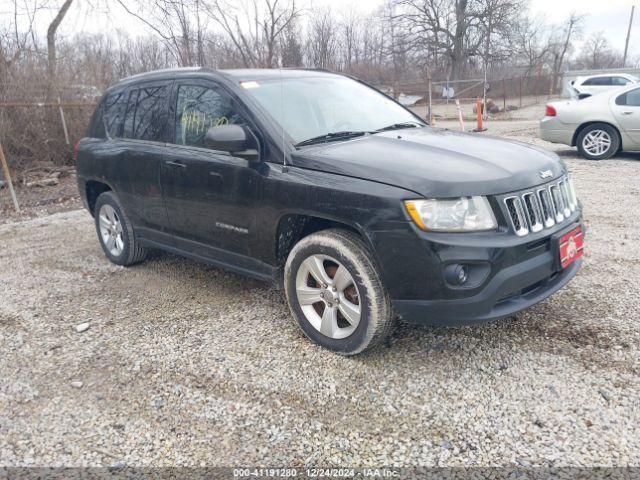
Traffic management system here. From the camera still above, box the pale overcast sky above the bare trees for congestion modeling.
[8,0,640,62]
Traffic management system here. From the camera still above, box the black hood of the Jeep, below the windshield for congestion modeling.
[292,127,566,197]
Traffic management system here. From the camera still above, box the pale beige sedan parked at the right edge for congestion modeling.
[540,85,640,160]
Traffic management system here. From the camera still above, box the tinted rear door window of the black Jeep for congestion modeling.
[122,86,168,141]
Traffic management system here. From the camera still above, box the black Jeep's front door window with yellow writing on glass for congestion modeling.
[175,85,246,147]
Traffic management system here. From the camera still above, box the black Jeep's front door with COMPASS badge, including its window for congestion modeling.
[161,80,261,263]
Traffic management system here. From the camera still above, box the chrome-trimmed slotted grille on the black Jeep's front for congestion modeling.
[504,177,578,236]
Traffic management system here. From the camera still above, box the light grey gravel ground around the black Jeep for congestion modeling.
[0,122,640,466]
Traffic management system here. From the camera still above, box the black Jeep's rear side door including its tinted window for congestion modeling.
[121,81,172,242]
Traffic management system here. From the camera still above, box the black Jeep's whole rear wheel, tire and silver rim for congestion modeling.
[94,192,147,267]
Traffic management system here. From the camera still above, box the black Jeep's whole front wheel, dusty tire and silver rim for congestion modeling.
[284,229,393,355]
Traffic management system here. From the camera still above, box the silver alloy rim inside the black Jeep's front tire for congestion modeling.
[296,255,362,339]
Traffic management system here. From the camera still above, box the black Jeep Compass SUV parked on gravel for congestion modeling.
[77,68,583,355]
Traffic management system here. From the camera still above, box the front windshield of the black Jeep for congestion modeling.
[242,76,423,143]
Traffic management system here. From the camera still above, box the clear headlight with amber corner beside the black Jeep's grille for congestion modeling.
[404,196,498,232]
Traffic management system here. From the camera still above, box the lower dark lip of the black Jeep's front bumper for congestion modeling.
[393,253,582,326]
